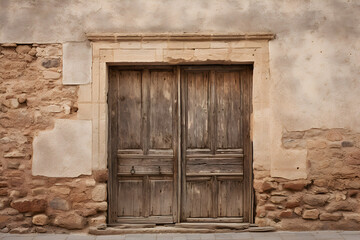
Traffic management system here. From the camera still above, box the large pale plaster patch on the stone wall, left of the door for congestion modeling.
[32,119,92,177]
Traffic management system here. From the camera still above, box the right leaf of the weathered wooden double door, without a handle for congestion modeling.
[181,66,251,222]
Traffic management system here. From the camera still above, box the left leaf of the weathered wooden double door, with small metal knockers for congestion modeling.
[108,67,178,223]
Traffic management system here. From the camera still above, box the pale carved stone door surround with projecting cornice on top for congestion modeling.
[84,33,275,226]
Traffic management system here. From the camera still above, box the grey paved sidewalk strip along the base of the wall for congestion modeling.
[0,231,360,240]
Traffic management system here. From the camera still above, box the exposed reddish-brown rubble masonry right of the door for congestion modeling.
[254,129,360,230]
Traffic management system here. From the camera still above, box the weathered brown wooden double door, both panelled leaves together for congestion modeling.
[108,65,252,224]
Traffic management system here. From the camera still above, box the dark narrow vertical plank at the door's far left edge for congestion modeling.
[107,69,119,224]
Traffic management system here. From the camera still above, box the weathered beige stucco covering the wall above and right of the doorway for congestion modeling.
[0,0,360,178]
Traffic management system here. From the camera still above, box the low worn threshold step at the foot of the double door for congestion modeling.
[89,223,276,235]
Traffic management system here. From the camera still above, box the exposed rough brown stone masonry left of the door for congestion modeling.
[0,44,107,233]
